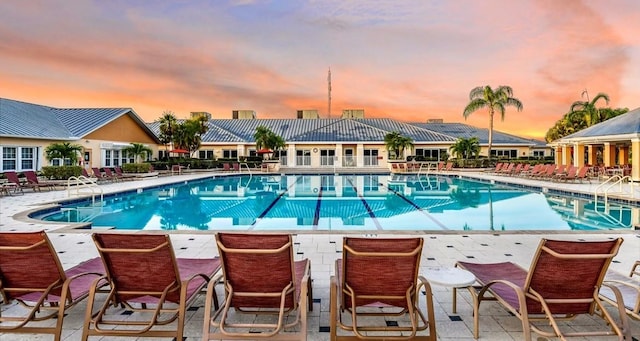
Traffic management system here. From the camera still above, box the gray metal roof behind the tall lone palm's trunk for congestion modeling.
[411,123,546,146]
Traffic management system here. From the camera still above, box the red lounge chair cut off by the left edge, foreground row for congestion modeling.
[0,231,106,341]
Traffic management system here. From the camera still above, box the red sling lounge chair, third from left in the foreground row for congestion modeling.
[203,233,313,340]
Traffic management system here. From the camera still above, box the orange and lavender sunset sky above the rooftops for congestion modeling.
[0,0,640,138]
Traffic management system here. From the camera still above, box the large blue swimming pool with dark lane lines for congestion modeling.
[37,174,640,231]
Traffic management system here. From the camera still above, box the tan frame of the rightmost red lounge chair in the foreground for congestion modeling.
[456,238,631,341]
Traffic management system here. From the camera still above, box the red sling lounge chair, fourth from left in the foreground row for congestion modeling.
[329,237,437,340]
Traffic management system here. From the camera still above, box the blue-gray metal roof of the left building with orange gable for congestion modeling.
[0,98,157,140]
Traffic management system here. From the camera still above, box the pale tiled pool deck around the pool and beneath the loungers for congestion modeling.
[0,173,640,341]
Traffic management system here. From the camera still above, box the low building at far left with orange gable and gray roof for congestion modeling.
[0,98,160,172]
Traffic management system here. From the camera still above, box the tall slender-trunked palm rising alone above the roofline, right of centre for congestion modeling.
[462,85,522,158]
